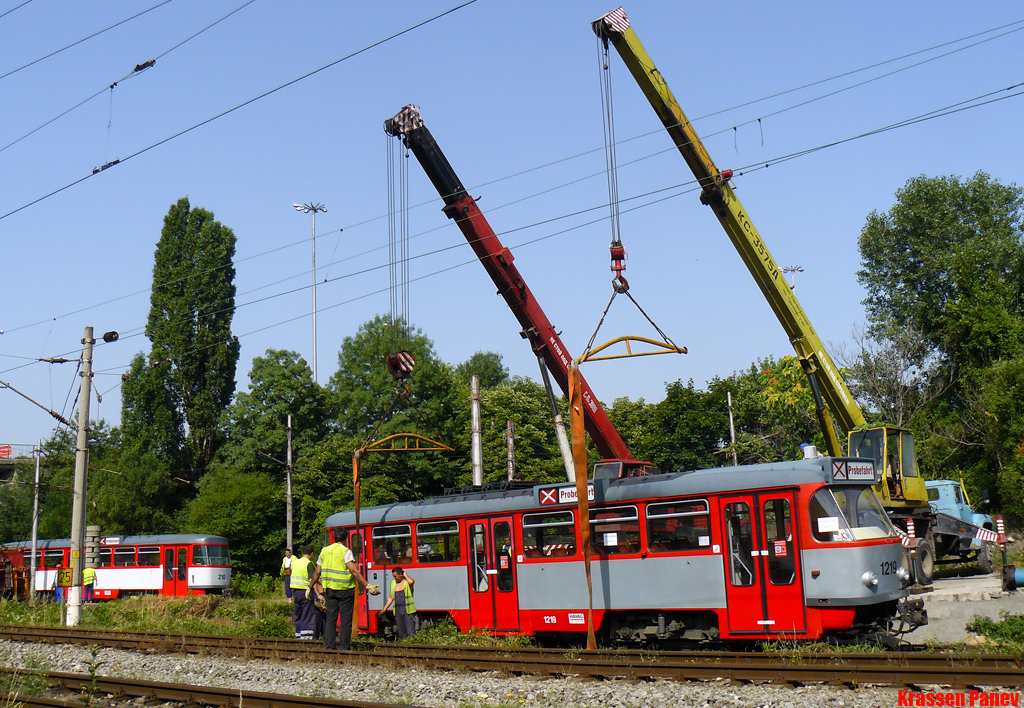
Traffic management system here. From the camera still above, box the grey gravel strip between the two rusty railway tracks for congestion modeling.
[0,641,913,708]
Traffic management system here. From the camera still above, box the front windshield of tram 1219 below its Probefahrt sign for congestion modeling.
[810,487,896,543]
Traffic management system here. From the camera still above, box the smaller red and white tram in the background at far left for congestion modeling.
[0,534,231,599]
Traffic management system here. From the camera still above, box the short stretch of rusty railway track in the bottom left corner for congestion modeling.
[0,668,419,708]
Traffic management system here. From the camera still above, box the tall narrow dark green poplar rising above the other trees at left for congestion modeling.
[123,197,239,480]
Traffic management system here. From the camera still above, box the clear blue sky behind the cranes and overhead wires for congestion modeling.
[0,0,1024,443]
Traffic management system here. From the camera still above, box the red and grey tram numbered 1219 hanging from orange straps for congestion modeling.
[327,458,928,643]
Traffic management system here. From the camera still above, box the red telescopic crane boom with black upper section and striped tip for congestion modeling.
[384,106,657,478]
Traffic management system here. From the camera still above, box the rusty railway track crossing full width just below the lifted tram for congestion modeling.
[0,626,1024,690]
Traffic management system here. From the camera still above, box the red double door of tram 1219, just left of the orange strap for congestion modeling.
[469,516,519,631]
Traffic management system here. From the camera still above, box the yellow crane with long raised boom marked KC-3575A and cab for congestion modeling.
[592,7,967,585]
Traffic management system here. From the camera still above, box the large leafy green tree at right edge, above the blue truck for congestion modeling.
[858,172,1024,509]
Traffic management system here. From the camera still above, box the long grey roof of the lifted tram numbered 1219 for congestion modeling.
[327,457,860,528]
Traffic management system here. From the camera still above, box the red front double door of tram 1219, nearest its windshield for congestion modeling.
[719,492,807,633]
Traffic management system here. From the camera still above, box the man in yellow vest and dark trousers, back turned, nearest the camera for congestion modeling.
[306,529,381,651]
